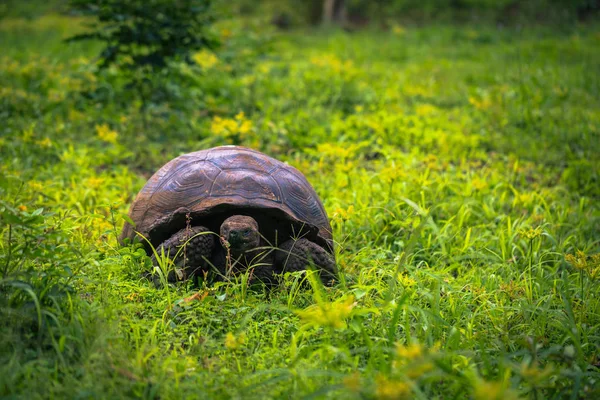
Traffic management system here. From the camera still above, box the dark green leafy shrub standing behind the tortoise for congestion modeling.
[69,0,217,108]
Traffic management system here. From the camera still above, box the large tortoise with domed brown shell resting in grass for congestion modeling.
[120,146,337,285]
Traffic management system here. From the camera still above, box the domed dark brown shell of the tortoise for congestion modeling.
[121,146,333,252]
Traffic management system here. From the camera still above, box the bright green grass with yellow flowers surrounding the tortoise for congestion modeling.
[0,17,600,399]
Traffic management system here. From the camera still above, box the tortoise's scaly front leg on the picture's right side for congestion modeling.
[275,239,337,285]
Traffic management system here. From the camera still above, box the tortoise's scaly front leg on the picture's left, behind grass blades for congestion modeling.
[151,226,215,284]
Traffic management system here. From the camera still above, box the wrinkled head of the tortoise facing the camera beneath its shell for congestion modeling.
[220,215,260,257]
